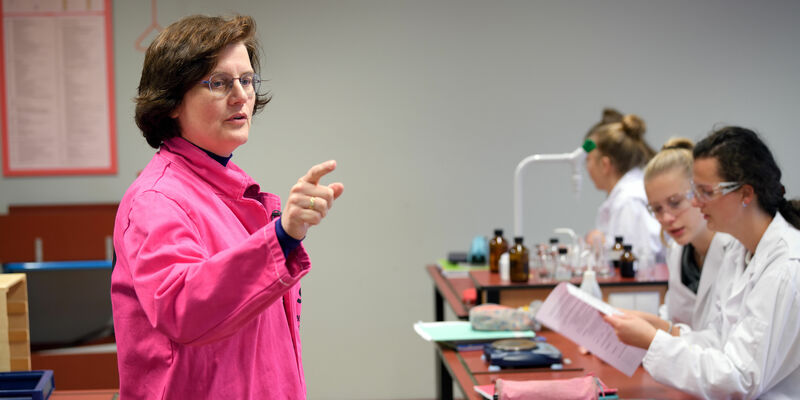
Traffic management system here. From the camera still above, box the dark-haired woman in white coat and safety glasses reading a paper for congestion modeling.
[604,127,800,399]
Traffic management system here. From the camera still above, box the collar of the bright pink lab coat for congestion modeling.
[158,137,261,199]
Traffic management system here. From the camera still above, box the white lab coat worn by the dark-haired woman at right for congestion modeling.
[643,213,800,399]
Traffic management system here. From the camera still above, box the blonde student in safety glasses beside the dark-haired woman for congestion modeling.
[628,138,736,336]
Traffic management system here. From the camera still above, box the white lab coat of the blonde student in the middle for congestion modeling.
[659,232,738,333]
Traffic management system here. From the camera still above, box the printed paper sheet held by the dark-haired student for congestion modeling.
[536,282,647,376]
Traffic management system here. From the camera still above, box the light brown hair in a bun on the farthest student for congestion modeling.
[586,111,655,175]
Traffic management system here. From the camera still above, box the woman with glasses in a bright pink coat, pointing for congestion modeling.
[111,16,344,400]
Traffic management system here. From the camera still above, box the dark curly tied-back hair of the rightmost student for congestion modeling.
[694,126,800,229]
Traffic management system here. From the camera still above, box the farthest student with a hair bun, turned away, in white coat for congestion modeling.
[586,109,664,261]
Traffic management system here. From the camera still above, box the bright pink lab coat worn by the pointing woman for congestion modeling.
[111,138,311,400]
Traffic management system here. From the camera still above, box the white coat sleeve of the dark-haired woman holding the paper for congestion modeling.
[643,268,800,398]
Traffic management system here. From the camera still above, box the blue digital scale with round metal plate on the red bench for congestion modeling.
[483,339,562,367]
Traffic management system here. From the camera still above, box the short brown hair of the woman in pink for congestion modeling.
[135,15,271,148]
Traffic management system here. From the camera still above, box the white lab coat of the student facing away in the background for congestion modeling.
[595,168,664,261]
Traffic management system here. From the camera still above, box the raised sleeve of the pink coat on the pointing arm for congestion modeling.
[118,191,310,345]
